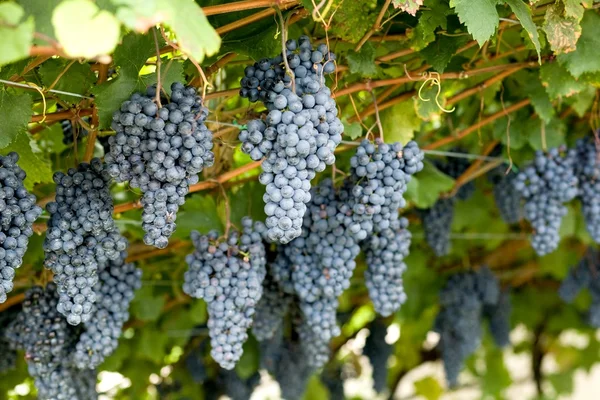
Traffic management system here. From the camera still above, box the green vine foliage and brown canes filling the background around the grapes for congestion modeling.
[0,0,600,399]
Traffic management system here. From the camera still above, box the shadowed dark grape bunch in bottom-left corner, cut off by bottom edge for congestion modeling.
[7,283,97,400]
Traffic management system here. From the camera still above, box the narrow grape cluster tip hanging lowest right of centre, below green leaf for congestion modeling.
[362,218,411,317]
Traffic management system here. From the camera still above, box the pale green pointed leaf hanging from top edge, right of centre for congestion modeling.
[450,0,500,46]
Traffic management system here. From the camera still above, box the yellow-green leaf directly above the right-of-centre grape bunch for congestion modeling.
[381,100,421,144]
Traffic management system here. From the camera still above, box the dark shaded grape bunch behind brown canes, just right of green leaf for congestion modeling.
[421,153,475,257]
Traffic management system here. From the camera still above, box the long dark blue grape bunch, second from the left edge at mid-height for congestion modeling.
[44,158,127,325]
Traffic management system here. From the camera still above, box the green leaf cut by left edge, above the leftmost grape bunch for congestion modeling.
[0,90,32,149]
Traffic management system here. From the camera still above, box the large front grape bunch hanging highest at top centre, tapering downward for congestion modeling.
[239,36,344,243]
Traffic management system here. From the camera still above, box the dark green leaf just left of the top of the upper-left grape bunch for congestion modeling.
[92,75,137,129]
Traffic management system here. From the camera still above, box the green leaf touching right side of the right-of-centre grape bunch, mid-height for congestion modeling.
[406,162,454,208]
